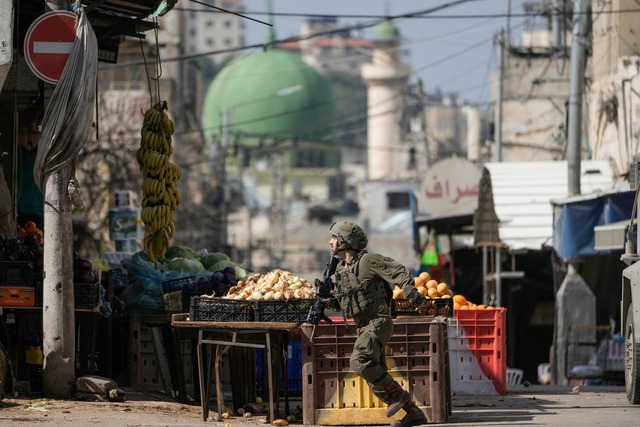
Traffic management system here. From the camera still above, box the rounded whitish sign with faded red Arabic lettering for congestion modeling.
[420,157,482,216]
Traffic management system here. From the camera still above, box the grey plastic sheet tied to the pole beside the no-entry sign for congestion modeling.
[33,7,98,196]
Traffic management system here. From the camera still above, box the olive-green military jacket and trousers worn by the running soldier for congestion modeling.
[335,249,422,410]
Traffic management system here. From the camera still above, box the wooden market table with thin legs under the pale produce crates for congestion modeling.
[171,313,300,421]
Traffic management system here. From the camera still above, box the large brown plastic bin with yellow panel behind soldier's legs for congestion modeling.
[301,317,451,425]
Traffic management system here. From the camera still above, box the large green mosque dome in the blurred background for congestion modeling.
[202,48,336,143]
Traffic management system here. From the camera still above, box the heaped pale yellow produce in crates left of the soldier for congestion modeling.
[203,269,315,301]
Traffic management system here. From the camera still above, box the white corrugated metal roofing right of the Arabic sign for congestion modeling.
[476,160,615,250]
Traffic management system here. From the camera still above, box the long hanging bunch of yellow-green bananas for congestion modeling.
[136,101,182,261]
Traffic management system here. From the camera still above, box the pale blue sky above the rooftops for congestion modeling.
[244,0,528,106]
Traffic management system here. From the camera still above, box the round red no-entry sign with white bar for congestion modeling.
[24,11,76,84]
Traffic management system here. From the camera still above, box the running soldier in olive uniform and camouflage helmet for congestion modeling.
[329,221,427,427]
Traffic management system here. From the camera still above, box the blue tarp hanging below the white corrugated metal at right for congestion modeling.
[551,190,635,261]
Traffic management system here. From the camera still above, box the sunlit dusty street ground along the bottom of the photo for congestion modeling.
[0,386,640,427]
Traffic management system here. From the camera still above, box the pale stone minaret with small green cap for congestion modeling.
[361,19,410,180]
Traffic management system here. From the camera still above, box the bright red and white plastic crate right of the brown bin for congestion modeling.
[448,307,507,395]
